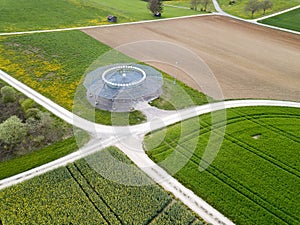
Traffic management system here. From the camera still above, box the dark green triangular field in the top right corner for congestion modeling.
[259,8,300,32]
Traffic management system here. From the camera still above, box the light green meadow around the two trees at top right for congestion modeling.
[218,0,300,19]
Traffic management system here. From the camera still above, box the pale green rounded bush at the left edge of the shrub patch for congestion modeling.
[0,116,28,149]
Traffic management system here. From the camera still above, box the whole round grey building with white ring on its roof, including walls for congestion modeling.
[83,64,163,112]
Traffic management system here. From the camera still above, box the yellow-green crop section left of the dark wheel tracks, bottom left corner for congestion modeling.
[0,168,105,225]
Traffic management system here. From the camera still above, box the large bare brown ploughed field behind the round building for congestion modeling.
[84,16,300,101]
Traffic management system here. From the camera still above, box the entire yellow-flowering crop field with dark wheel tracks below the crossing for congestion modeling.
[0,148,203,225]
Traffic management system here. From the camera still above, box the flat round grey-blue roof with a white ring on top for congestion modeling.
[83,63,163,100]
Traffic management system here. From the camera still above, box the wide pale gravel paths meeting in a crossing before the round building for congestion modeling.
[0,70,300,225]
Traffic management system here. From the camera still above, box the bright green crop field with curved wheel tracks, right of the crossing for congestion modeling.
[145,107,300,225]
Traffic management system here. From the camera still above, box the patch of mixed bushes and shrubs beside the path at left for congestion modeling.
[0,86,71,160]
